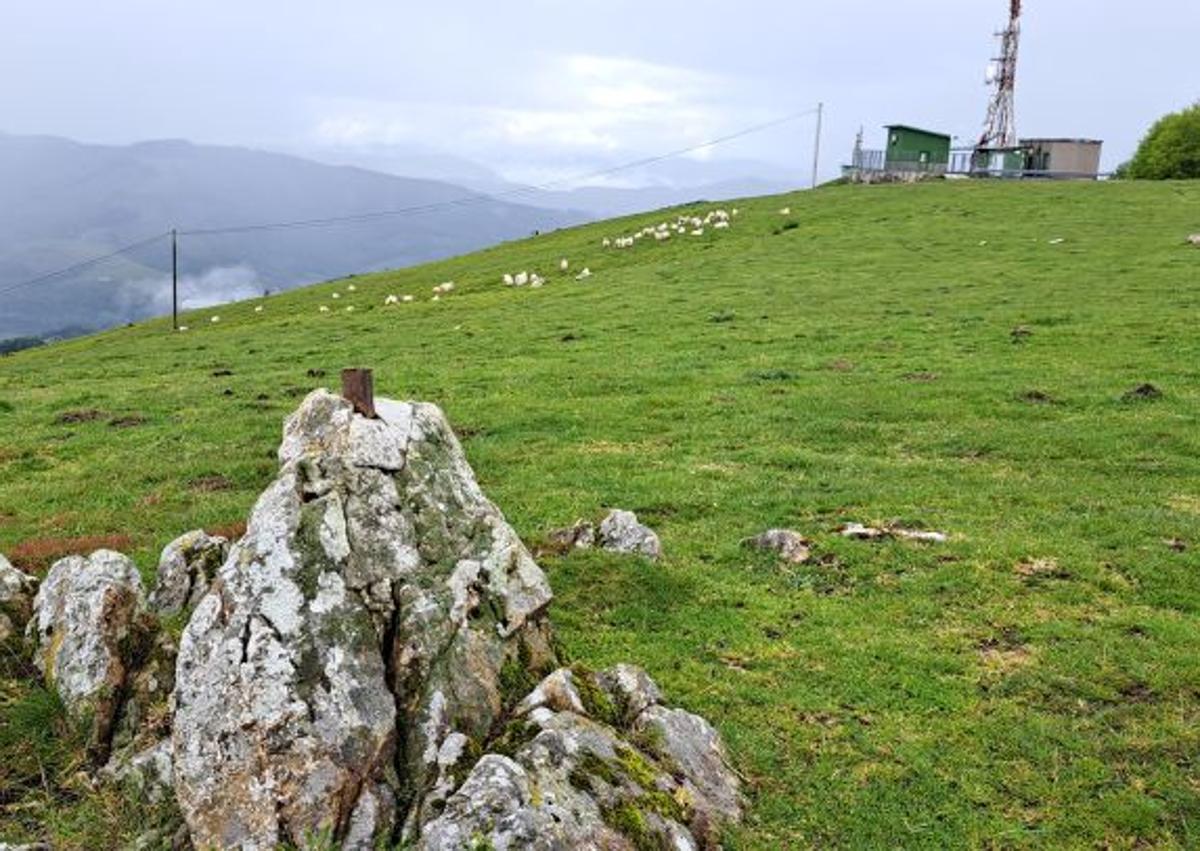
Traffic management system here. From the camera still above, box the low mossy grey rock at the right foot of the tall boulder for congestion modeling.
[416,665,740,851]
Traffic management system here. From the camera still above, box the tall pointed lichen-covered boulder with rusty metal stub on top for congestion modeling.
[173,391,554,849]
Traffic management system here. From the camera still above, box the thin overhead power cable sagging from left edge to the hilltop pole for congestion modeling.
[0,108,820,295]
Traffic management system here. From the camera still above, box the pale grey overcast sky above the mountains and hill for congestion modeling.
[0,0,1200,180]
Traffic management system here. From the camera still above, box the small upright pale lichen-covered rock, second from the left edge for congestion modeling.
[26,550,145,748]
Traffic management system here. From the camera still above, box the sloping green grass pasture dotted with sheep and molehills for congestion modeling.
[0,177,1200,849]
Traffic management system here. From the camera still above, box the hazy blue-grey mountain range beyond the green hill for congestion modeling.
[0,133,806,340]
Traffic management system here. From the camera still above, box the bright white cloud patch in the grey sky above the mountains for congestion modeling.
[304,53,763,182]
